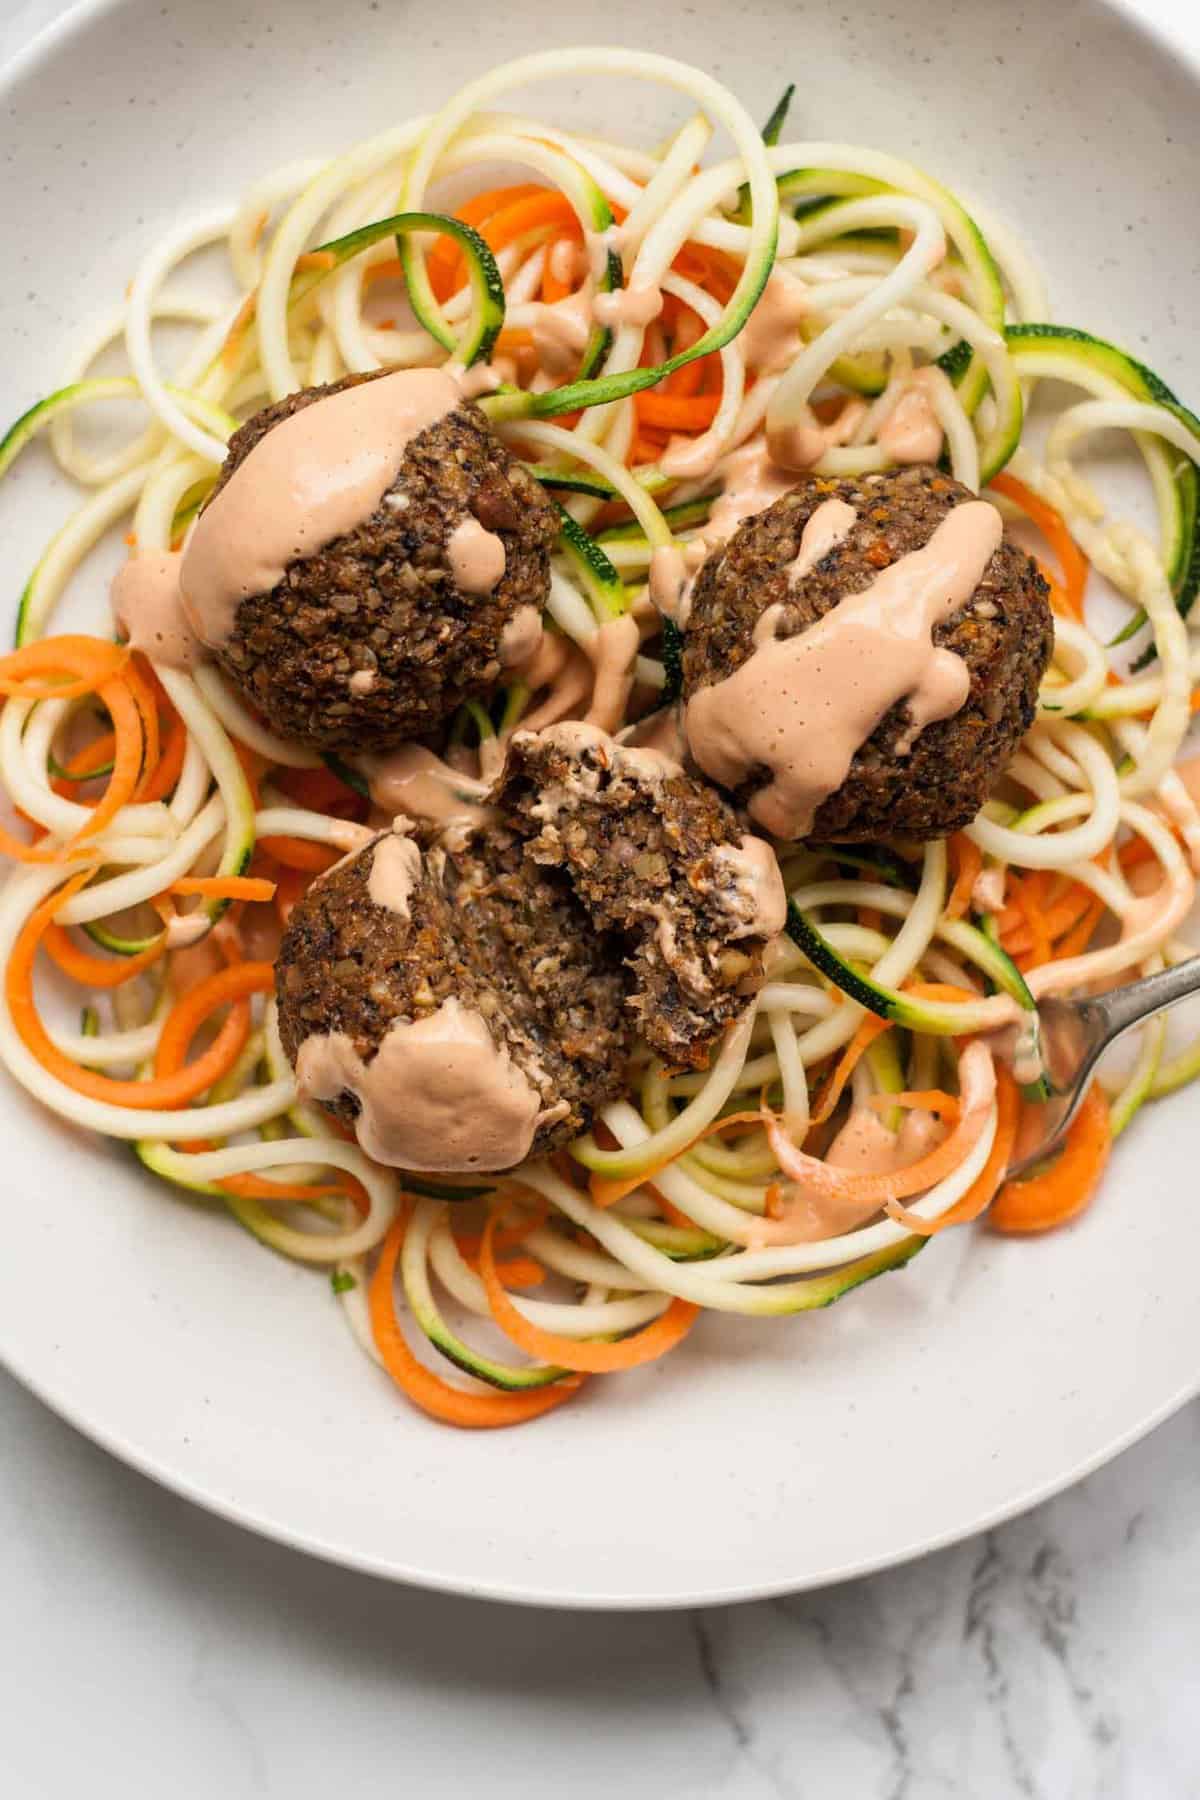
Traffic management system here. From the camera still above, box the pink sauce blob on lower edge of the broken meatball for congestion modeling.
[295,999,542,1174]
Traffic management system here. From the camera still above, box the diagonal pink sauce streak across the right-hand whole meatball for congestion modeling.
[685,500,1002,839]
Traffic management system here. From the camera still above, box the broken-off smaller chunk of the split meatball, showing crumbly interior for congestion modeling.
[493,724,786,1067]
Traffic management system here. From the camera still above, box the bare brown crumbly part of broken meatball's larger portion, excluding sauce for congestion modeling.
[275,830,630,1156]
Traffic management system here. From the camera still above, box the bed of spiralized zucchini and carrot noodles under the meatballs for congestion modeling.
[0,49,1200,1424]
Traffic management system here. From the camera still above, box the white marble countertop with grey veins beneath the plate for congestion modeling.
[0,0,1200,1800]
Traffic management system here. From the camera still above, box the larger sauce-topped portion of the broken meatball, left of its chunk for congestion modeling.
[275,830,630,1174]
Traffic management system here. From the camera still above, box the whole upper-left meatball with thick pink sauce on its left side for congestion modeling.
[182,369,558,751]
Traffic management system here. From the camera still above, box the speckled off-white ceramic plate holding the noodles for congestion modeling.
[0,0,1200,1606]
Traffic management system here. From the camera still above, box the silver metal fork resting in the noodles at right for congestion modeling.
[1007,956,1200,1177]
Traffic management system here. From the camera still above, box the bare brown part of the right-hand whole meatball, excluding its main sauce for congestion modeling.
[684,466,1052,842]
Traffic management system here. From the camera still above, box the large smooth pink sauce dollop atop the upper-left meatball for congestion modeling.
[180,369,461,648]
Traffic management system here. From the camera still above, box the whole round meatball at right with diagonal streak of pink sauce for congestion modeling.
[684,466,1052,842]
